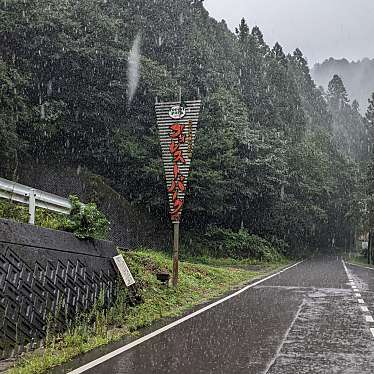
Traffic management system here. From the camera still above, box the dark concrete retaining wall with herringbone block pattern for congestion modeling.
[0,219,117,358]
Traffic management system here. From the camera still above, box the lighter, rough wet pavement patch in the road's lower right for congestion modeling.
[266,279,374,374]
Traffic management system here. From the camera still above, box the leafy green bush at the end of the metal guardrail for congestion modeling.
[63,195,109,239]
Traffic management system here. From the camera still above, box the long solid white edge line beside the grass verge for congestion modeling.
[68,261,304,374]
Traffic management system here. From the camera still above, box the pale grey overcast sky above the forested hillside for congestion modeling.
[204,0,374,66]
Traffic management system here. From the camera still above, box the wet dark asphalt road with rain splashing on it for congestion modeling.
[67,256,374,374]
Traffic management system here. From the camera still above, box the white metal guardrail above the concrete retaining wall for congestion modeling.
[0,178,71,225]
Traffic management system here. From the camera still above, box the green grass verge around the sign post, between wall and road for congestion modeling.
[8,250,287,374]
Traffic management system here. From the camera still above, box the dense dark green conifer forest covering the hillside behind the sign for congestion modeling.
[0,0,374,251]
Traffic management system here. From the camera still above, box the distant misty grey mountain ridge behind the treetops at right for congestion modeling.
[311,57,374,114]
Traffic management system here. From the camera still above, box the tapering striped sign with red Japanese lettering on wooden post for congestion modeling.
[156,100,201,222]
